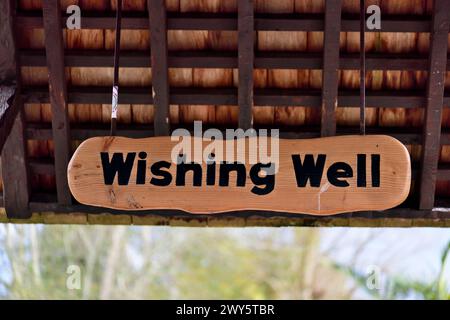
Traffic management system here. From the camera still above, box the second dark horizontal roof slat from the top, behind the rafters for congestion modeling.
[19,49,450,71]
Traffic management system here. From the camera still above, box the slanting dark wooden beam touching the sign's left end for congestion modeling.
[43,0,72,204]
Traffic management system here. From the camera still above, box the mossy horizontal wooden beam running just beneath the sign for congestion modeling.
[16,200,450,228]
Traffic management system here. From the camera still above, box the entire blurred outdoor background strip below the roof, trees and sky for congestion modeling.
[0,224,450,300]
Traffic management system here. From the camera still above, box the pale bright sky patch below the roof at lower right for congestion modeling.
[321,228,450,281]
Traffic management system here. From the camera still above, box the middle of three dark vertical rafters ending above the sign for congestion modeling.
[238,0,254,130]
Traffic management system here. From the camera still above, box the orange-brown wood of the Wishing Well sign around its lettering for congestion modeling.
[68,135,411,215]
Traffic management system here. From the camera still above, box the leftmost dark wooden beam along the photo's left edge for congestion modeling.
[0,0,30,218]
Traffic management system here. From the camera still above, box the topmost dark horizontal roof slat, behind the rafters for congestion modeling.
[18,12,431,32]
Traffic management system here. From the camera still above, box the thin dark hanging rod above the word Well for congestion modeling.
[359,0,366,135]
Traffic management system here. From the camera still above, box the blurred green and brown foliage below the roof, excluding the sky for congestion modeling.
[0,225,449,299]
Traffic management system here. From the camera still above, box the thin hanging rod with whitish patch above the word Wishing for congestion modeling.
[111,0,122,136]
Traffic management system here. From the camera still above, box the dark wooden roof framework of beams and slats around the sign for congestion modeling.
[0,0,450,227]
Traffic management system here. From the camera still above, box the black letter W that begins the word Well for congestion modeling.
[292,154,327,187]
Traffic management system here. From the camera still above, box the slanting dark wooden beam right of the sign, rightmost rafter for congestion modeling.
[419,0,450,209]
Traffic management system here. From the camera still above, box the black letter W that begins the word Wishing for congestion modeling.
[100,152,136,186]
